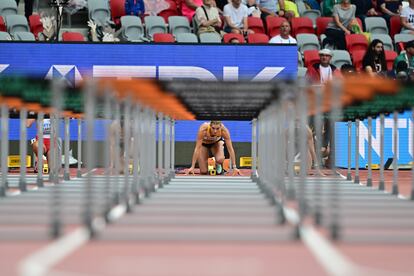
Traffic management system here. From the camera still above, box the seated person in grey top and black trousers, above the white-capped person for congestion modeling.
[322,0,358,50]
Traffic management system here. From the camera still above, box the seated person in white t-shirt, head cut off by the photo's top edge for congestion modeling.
[224,0,253,35]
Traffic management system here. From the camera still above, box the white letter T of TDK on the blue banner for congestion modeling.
[92,65,157,79]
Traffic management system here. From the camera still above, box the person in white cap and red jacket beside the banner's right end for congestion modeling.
[306,49,341,84]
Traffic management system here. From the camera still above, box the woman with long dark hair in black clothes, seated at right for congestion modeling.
[362,39,387,76]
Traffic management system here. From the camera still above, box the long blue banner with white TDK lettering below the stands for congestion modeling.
[0,42,298,85]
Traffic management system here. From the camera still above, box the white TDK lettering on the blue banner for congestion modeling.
[93,65,285,81]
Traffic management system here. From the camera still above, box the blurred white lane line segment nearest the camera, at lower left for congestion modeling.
[18,227,89,276]
